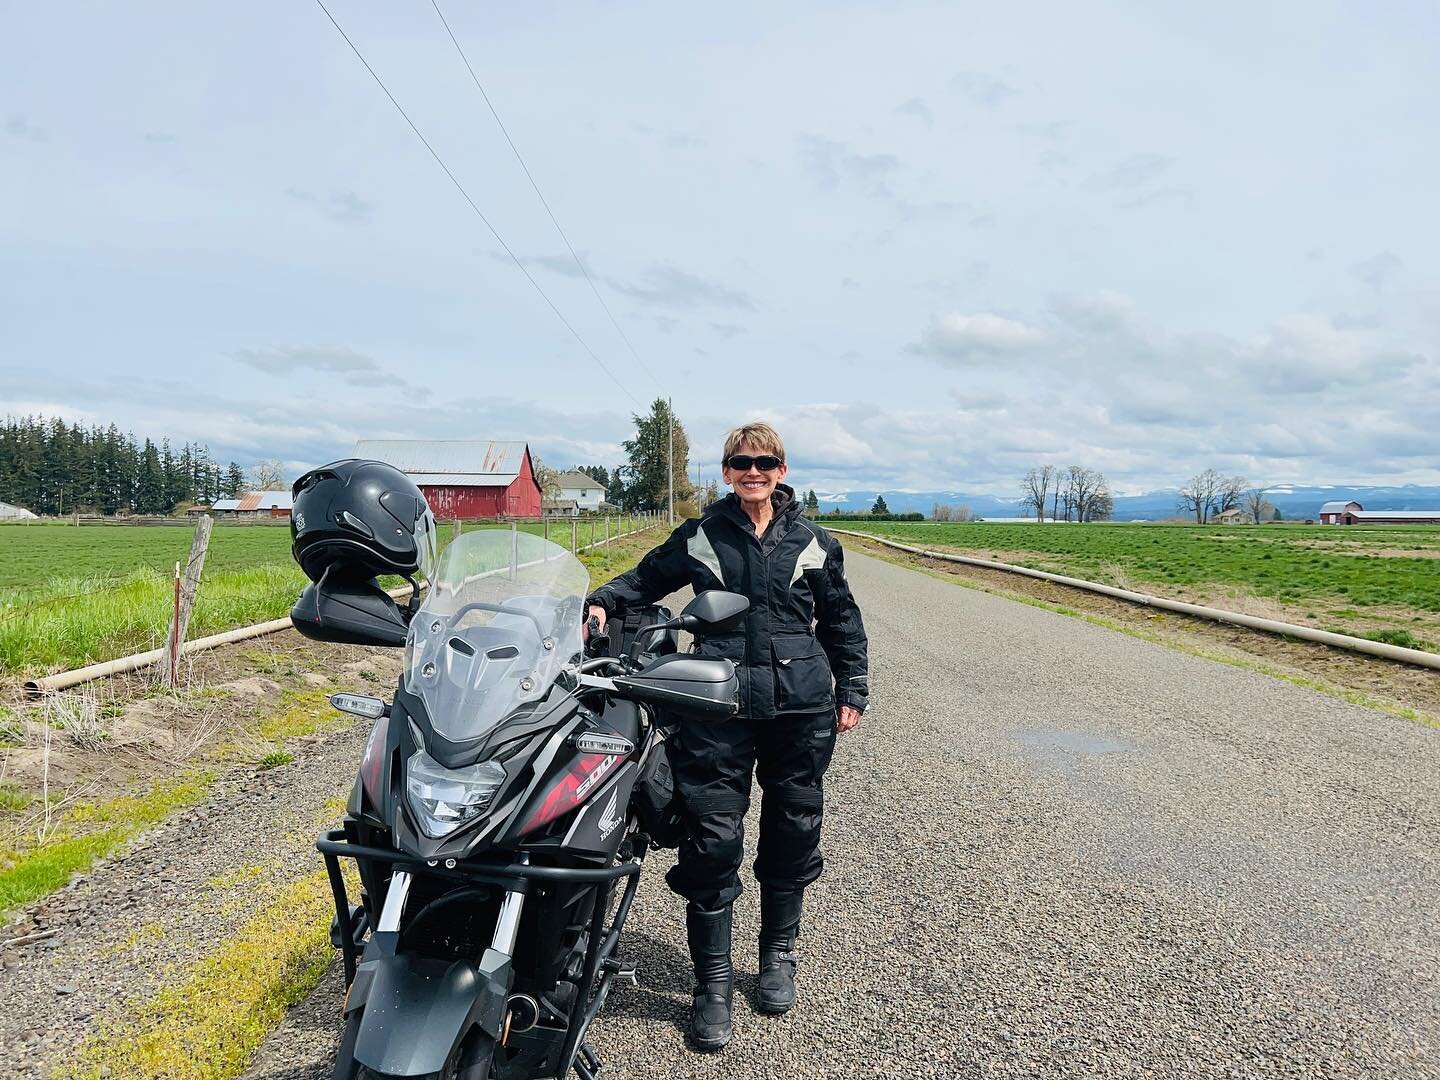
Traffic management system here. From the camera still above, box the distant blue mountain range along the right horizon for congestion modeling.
[816,484,1440,521]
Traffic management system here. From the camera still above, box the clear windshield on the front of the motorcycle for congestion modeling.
[405,528,590,742]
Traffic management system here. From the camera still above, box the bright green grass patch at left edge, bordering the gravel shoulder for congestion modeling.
[0,772,215,916]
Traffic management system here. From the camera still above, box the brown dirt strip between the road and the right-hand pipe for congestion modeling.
[845,537,1440,723]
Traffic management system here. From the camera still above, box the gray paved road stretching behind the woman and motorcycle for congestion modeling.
[253,554,1440,1080]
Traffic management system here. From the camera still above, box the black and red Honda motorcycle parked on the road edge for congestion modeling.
[291,530,749,1080]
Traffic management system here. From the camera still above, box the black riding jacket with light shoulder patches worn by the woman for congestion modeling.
[588,484,870,719]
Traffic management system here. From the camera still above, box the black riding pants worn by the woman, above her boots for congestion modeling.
[667,710,835,910]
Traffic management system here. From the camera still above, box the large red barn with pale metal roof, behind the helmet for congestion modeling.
[354,439,540,521]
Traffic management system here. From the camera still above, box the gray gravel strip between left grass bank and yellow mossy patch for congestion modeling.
[0,657,399,1077]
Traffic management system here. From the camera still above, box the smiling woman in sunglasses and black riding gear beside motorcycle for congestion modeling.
[588,423,868,1050]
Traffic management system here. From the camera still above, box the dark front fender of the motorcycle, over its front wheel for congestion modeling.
[347,949,511,1076]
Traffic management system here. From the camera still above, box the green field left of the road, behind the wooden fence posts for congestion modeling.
[0,518,659,674]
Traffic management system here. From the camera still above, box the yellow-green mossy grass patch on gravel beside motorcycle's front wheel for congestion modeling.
[62,871,342,1080]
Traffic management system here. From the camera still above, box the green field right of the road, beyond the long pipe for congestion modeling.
[835,521,1440,651]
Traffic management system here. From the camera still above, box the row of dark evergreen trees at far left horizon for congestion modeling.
[0,416,246,514]
